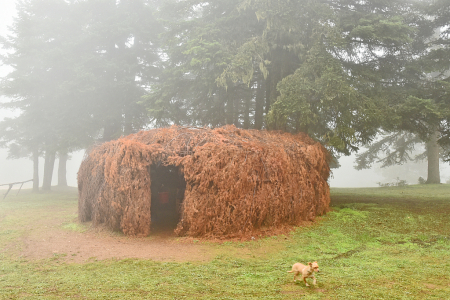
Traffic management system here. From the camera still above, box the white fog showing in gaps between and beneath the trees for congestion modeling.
[0,0,450,189]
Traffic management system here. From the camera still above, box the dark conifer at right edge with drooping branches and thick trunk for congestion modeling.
[357,1,450,184]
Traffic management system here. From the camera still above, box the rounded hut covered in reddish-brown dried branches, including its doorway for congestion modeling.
[78,126,330,237]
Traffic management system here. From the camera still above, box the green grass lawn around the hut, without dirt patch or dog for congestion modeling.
[0,185,450,299]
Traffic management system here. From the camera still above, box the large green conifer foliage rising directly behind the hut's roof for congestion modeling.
[150,0,417,154]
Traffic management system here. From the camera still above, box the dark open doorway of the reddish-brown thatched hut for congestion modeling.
[150,165,186,232]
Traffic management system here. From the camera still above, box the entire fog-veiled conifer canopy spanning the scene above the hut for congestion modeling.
[0,0,450,188]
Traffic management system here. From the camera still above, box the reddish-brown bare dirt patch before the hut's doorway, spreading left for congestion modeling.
[0,200,215,263]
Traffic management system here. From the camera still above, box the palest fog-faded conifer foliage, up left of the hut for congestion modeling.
[0,0,159,188]
